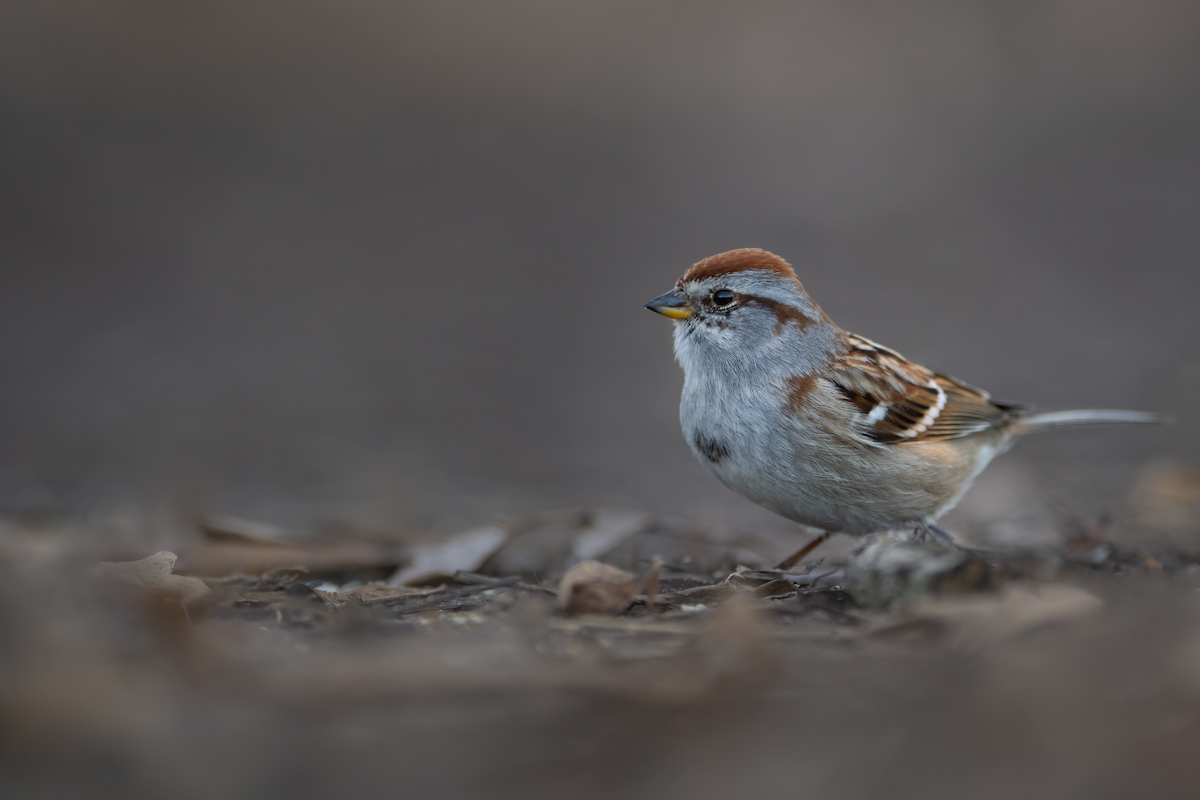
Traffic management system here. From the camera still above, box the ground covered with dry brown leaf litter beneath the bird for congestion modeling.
[7,511,1200,798]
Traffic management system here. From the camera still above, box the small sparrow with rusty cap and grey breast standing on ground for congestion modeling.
[646,248,1170,554]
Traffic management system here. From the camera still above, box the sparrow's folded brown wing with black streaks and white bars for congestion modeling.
[827,333,1016,444]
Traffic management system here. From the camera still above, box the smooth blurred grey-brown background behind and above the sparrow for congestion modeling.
[0,0,1200,530]
